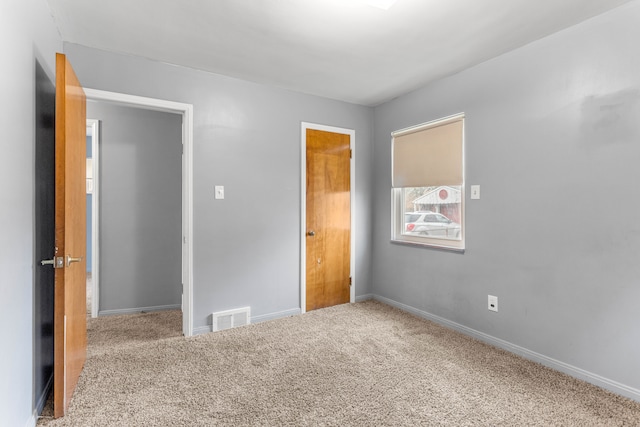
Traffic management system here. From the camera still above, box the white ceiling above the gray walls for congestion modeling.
[48,0,630,105]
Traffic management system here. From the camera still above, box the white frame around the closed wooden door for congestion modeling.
[300,122,356,313]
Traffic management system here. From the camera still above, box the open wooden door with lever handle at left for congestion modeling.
[53,54,87,418]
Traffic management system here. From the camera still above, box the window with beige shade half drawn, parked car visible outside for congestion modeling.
[391,114,464,251]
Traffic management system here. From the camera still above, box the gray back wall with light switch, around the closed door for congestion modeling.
[65,44,373,330]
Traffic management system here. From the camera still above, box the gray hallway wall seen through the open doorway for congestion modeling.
[87,101,182,314]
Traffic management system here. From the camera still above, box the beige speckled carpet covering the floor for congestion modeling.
[38,301,640,427]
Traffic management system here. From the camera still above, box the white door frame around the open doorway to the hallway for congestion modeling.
[84,88,193,337]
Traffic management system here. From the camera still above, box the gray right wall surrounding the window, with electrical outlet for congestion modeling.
[372,1,640,399]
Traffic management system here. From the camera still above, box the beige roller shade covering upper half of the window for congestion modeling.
[391,115,464,188]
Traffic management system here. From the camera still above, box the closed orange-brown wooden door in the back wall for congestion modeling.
[305,129,351,311]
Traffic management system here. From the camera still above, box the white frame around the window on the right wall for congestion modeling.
[391,113,466,253]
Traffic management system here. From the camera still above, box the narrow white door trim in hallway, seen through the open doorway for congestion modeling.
[85,118,100,319]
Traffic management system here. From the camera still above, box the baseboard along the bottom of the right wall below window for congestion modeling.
[373,295,640,402]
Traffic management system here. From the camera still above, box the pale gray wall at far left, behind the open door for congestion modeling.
[0,0,62,426]
